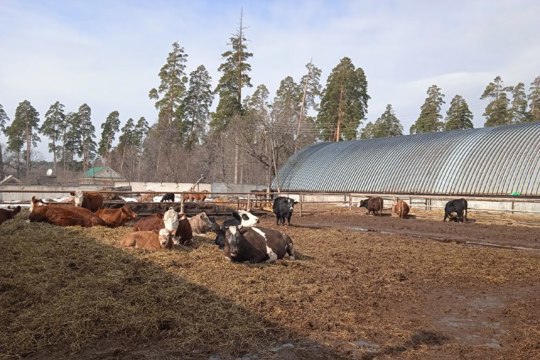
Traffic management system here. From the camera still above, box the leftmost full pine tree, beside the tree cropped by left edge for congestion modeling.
[6,100,39,176]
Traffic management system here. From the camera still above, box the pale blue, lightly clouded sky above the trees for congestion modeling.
[0,0,540,159]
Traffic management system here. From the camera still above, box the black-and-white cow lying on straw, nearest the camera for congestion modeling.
[223,225,294,263]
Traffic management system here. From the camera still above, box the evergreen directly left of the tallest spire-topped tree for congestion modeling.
[183,65,214,149]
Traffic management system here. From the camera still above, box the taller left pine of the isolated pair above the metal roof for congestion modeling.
[409,85,445,134]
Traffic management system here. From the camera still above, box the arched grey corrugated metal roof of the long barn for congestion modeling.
[273,123,540,196]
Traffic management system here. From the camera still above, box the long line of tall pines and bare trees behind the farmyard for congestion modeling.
[0,15,540,184]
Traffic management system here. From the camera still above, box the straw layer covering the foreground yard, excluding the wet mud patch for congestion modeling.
[0,213,540,359]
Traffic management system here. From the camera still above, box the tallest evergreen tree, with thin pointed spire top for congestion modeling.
[210,15,253,132]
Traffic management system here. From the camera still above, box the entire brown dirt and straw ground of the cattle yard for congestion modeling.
[0,208,540,360]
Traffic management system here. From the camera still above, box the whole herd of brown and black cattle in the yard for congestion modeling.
[0,191,467,263]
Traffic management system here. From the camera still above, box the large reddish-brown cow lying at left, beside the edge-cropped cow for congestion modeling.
[28,196,105,227]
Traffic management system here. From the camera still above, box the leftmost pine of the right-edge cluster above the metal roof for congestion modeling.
[480,76,512,126]
